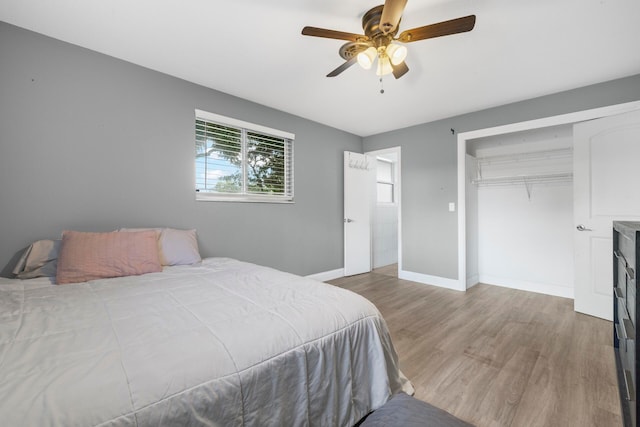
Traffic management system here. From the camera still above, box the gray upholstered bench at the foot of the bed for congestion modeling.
[359,393,473,427]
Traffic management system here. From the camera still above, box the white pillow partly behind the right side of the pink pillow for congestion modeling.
[119,228,202,265]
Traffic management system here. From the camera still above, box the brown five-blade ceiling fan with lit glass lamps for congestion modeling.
[302,0,476,79]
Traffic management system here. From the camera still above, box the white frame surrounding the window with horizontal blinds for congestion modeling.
[194,109,295,203]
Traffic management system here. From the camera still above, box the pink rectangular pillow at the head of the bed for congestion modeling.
[56,230,162,285]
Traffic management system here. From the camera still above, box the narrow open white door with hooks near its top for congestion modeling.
[344,151,375,276]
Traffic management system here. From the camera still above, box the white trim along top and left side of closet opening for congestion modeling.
[458,101,640,289]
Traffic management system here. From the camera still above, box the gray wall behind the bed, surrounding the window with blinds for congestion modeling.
[0,22,362,275]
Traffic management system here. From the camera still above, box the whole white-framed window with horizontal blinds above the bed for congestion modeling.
[195,110,294,203]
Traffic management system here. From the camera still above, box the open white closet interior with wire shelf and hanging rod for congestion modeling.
[466,125,574,298]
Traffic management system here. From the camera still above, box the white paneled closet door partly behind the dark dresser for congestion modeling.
[573,110,640,320]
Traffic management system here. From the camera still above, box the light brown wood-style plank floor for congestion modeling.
[329,266,622,427]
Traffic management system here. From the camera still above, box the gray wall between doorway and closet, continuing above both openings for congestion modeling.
[364,74,640,279]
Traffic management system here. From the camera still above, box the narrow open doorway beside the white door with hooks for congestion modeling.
[365,147,402,277]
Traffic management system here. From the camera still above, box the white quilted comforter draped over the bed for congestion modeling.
[0,258,411,427]
